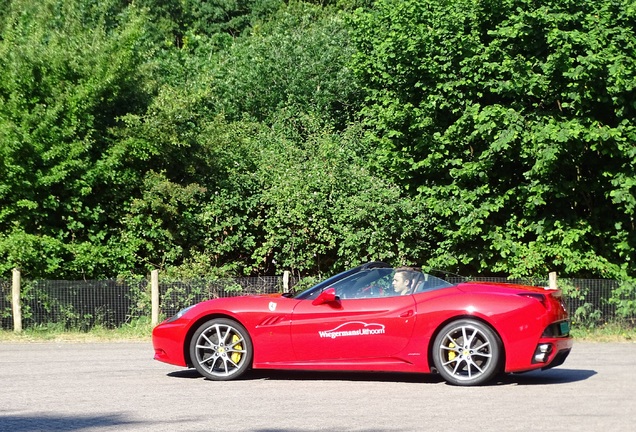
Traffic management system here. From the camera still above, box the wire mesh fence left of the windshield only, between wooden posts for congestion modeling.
[0,276,296,330]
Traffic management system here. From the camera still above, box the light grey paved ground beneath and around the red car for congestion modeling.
[0,342,636,432]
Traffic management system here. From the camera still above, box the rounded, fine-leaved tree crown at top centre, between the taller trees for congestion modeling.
[207,2,360,127]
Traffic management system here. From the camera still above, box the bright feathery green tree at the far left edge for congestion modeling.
[0,0,150,277]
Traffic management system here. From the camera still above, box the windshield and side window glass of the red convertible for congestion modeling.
[295,267,454,300]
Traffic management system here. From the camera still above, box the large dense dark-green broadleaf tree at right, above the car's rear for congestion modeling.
[352,0,636,276]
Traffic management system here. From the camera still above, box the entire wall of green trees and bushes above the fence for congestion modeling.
[0,0,636,286]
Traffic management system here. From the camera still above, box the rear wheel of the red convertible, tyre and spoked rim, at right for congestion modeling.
[432,319,502,386]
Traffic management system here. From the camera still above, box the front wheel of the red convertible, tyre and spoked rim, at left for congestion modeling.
[190,318,254,381]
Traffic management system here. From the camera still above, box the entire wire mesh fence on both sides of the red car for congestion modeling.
[0,276,636,330]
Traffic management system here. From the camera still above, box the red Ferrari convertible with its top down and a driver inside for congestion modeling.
[152,262,572,385]
